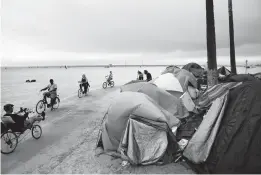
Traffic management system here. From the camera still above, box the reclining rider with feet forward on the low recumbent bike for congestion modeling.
[2,104,45,129]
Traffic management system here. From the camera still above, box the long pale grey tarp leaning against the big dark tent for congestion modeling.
[183,92,228,164]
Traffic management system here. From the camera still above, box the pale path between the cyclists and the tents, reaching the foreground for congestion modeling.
[1,87,193,174]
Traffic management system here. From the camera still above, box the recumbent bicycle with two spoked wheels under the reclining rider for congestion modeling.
[1,108,45,154]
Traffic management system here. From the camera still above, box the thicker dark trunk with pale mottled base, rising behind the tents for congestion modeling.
[206,0,218,87]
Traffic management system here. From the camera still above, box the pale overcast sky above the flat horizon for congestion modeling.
[1,0,261,66]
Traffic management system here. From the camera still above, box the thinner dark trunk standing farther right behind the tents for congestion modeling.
[228,0,237,74]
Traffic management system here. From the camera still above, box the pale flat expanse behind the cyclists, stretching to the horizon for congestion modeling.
[1,67,261,113]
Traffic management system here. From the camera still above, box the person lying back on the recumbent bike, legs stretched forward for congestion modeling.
[1,104,45,133]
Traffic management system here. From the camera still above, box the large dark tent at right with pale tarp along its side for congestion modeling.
[184,80,261,174]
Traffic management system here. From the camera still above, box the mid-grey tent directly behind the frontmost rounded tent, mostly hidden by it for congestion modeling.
[121,82,189,119]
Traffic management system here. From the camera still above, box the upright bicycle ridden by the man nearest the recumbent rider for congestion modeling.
[35,92,60,114]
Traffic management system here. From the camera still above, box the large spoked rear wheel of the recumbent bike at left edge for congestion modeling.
[1,131,18,154]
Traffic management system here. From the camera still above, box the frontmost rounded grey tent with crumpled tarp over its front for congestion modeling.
[96,92,180,165]
